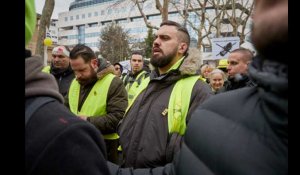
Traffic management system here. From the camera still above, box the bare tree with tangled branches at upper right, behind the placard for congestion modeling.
[171,0,253,49]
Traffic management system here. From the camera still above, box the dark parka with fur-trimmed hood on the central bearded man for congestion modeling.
[118,49,212,168]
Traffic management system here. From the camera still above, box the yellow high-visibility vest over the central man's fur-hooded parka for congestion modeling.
[126,75,203,135]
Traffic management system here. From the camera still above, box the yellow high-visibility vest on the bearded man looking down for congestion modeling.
[68,74,119,140]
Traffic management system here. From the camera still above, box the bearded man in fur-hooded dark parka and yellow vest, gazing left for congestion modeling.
[118,21,211,168]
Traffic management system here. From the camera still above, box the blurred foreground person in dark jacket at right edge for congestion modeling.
[158,0,289,175]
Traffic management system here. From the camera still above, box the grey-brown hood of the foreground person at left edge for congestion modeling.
[25,56,63,103]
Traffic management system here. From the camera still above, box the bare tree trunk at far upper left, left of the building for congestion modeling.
[35,0,55,56]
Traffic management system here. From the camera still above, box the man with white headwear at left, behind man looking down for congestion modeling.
[43,46,75,96]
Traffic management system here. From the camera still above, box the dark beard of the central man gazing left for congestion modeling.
[150,48,177,68]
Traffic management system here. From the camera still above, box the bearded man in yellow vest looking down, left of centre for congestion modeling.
[65,44,127,163]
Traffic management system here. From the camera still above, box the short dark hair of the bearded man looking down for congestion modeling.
[70,44,96,63]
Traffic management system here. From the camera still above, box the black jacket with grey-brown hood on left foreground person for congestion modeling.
[25,54,109,175]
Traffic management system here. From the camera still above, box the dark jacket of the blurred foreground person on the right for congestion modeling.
[108,56,288,175]
